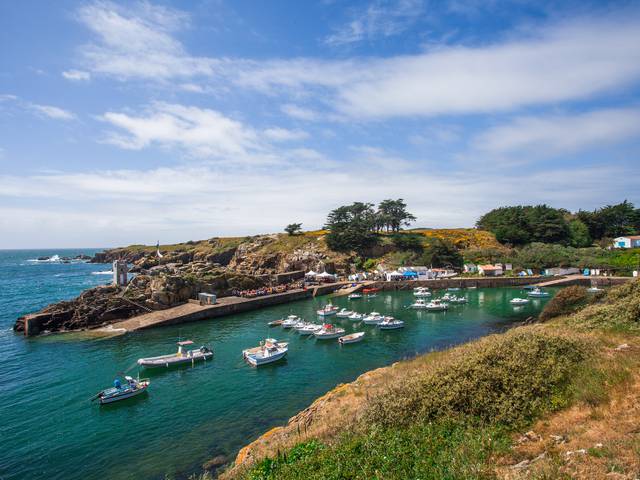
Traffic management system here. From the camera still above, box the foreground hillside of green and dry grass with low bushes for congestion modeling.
[219,281,640,480]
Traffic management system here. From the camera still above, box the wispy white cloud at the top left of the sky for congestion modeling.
[77,2,217,80]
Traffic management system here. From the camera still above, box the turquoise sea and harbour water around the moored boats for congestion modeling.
[0,250,545,480]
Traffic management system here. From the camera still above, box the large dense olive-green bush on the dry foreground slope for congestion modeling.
[364,330,586,427]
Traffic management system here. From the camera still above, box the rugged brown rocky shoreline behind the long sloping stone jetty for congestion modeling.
[14,235,349,333]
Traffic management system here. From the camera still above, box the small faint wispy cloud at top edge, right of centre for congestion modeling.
[324,0,424,46]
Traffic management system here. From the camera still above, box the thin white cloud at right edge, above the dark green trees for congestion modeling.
[473,108,640,156]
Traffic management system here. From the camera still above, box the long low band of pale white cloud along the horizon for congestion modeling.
[0,162,637,248]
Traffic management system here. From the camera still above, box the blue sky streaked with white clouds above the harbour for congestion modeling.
[0,0,640,248]
